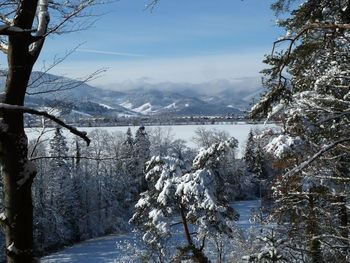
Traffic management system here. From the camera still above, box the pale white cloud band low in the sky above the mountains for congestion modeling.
[39,51,265,85]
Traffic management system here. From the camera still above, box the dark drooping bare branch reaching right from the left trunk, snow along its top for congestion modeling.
[0,103,90,145]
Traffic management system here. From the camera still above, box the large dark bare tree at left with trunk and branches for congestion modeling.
[0,0,98,263]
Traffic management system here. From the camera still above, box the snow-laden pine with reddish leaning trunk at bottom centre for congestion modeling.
[131,139,239,262]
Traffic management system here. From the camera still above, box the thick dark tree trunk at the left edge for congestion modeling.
[0,0,37,263]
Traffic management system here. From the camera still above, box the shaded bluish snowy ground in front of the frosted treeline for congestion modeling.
[41,200,259,263]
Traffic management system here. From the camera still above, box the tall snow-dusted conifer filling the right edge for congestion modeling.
[252,0,350,263]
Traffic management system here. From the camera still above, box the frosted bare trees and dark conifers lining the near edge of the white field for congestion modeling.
[0,127,266,260]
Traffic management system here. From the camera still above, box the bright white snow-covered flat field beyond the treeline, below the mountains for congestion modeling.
[26,122,274,157]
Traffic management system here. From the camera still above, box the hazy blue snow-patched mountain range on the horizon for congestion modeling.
[0,72,261,117]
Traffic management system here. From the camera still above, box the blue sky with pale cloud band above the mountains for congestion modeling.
[30,0,281,89]
